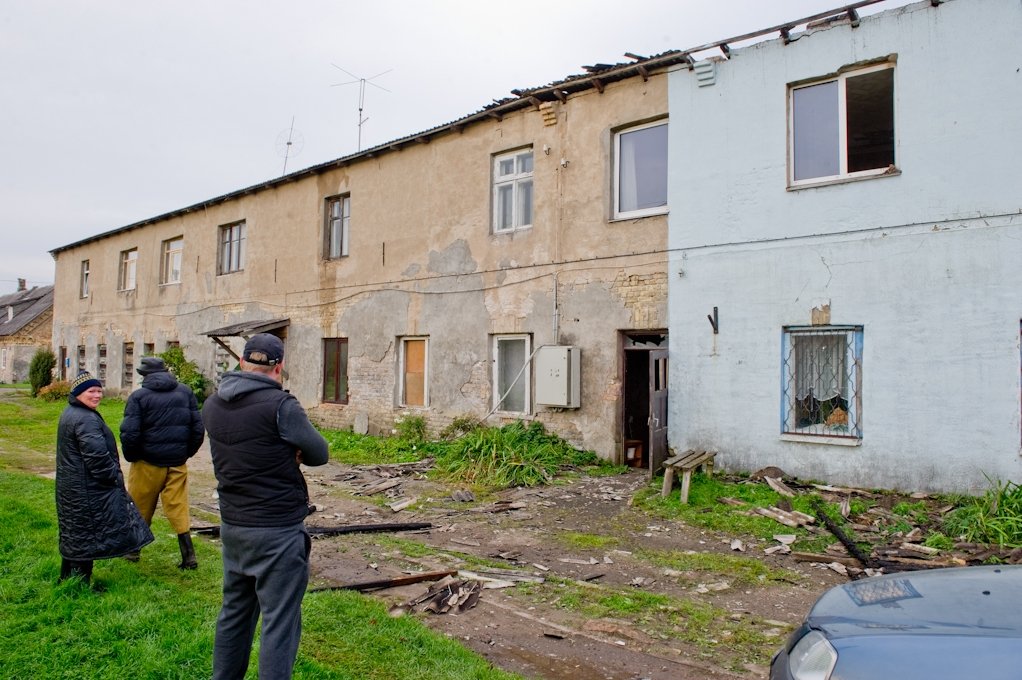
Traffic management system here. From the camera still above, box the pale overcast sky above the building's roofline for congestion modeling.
[0,0,909,288]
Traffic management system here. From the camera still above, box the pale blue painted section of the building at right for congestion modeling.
[668,0,1022,492]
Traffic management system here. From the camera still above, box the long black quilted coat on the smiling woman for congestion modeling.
[56,397,153,560]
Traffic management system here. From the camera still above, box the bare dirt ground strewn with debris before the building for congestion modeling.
[183,447,847,680]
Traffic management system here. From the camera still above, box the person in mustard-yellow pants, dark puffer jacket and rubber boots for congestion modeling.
[121,357,205,569]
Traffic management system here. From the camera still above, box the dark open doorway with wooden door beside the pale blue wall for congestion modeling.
[620,330,667,474]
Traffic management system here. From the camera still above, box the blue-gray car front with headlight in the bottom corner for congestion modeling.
[770,565,1022,680]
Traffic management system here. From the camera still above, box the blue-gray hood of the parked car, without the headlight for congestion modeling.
[806,565,1022,647]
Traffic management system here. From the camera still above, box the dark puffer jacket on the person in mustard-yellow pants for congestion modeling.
[121,371,205,467]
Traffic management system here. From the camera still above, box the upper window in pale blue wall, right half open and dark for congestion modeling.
[789,64,894,184]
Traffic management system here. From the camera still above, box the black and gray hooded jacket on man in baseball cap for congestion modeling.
[202,371,329,527]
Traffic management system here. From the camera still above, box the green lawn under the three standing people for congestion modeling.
[0,470,515,680]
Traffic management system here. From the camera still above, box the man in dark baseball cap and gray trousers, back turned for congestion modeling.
[202,333,329,680]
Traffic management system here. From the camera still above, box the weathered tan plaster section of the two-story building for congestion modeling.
[52,52,688,464]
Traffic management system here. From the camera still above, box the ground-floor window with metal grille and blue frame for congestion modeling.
[781,326,863,439]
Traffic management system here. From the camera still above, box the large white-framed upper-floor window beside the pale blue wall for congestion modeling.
[614,121,667,218]
